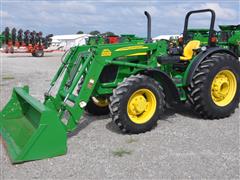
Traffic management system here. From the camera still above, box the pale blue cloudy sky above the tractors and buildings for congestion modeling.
[0,0,240,37]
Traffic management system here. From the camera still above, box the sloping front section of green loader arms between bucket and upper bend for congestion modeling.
[44,46,104,131]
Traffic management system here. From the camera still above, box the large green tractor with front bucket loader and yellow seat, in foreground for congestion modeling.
[0,9,240,163]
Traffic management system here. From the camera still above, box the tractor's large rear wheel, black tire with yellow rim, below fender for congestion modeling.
[188,54,240,119]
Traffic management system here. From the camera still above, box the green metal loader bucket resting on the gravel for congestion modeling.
[0,86,67,163]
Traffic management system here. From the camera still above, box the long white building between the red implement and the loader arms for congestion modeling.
[48,34,91,51]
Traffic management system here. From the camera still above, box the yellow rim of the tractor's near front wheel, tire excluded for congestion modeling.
[127,89,157,124]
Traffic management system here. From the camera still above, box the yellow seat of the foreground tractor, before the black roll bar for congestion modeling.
[180,40,200,61]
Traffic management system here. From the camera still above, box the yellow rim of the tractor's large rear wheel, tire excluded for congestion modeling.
[211,70,237,107]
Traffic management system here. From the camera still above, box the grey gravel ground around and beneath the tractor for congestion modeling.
[0,53,240,179]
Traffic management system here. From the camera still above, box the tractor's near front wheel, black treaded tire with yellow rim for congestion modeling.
[109,75,165,133]
